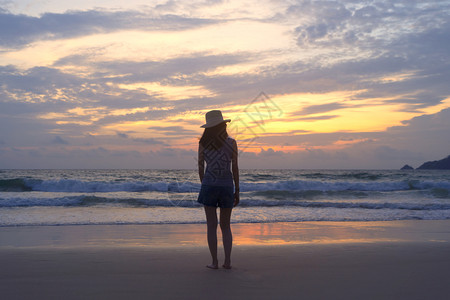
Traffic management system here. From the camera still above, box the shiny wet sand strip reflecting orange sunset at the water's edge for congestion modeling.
[0,220,450,249]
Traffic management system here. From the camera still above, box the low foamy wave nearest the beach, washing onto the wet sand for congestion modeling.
[0,206,450,226]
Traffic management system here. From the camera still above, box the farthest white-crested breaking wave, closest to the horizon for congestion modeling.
[0,178,450,195]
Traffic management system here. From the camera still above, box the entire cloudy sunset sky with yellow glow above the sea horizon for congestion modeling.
[0,0,450,169]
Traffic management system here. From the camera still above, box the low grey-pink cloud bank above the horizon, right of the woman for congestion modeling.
[241,103,450,169]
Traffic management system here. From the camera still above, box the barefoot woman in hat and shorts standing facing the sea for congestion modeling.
[197,110,239,269]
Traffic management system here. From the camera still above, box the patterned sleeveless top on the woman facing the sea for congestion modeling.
[202,137,234,186]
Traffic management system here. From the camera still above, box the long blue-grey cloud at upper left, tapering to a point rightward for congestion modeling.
[0,10,216,47]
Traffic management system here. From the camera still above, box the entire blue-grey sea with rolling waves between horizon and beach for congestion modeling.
[0,170,450,226]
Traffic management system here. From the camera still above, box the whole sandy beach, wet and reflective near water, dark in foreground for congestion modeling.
[0,221,450,299]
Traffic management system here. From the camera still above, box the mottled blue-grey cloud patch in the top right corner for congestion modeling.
[286,1,450,51]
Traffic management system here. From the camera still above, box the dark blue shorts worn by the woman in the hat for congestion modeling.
[197,184,234,208]
